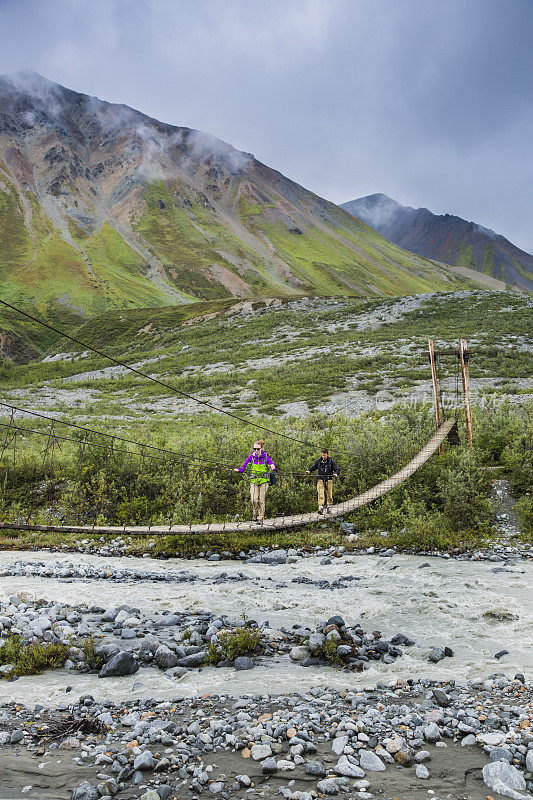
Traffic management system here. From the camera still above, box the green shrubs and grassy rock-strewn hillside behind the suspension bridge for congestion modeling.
[0,292,533,554]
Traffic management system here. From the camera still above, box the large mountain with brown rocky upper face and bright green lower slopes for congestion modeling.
[0,73,474,338]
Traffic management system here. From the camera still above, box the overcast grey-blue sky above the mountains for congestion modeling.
[0,0,533,253]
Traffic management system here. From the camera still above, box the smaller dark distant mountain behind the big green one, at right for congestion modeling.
[342,194,533,292]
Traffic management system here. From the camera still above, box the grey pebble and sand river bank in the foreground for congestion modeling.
[0,676,533,800]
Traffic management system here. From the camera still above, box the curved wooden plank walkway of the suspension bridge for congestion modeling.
[0,420,456,536]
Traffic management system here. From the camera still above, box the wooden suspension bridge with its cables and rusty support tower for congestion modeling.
[0,300,472,536]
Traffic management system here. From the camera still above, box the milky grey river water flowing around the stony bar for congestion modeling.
[0,552,533,705]
